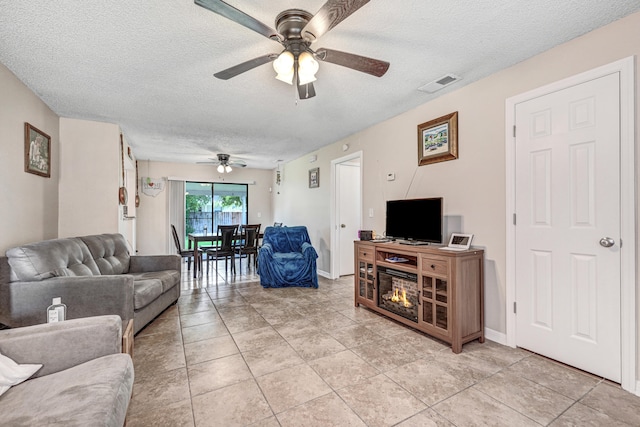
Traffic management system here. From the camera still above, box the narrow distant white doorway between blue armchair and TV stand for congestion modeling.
[331,151,362,279]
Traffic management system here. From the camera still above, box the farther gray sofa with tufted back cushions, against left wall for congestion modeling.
[0,234,181,333]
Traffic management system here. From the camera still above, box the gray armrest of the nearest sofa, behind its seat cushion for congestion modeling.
[0,316,122,378]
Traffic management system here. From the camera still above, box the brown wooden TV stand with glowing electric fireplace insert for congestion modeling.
[354,241,484,353]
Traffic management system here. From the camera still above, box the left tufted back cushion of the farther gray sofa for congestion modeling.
[7,238,100,282]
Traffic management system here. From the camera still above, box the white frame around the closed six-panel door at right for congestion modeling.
[505,56,640,394]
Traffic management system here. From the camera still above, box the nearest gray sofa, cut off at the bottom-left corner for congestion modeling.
[0,316,134,427]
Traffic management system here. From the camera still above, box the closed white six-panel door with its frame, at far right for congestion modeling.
[506,59,636,390]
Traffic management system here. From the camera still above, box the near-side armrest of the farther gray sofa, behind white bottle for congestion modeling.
[0,274,133,327]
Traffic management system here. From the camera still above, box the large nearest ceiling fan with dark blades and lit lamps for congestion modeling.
[194,0,389,99]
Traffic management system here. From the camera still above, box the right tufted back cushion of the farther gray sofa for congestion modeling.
[79,234,129,274]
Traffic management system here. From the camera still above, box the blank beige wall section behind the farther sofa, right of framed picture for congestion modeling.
[58,118,122,237]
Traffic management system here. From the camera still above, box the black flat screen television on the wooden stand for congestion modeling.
[386,197,443,243]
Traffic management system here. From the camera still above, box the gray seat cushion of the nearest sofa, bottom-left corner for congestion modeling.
[0,354,133,427]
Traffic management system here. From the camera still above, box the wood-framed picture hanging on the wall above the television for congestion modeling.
[418,111,458,166]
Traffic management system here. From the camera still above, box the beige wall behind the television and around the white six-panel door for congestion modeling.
[274,13,640,342]
